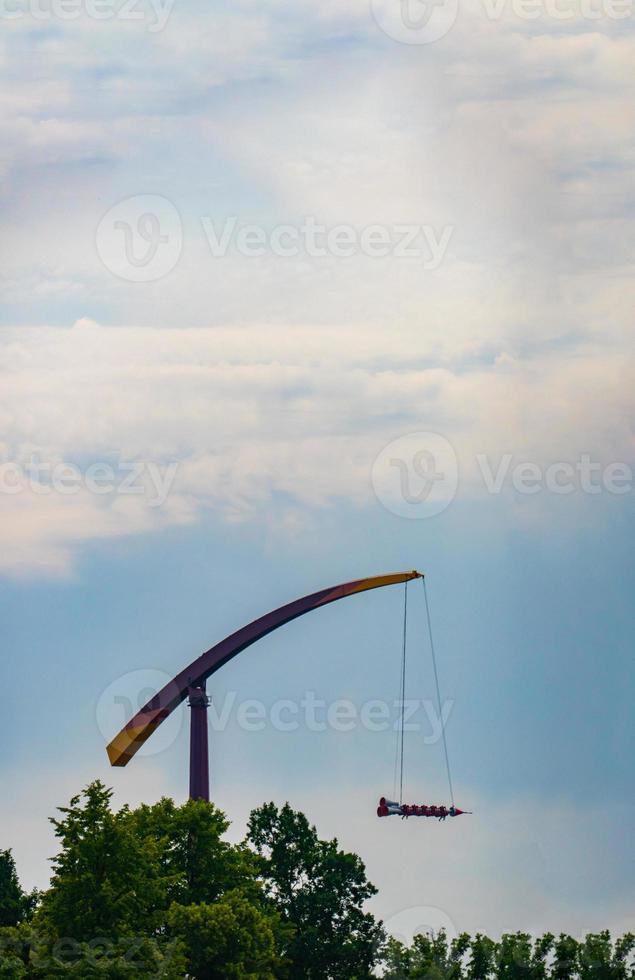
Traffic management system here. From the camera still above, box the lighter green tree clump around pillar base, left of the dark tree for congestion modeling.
[29,781,282,980]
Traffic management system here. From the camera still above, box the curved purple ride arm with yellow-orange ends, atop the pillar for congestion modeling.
[107,571,423,766]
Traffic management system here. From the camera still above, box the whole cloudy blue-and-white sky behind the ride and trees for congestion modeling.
[0,0,635,938]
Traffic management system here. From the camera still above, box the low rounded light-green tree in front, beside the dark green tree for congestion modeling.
[170,890,280,980]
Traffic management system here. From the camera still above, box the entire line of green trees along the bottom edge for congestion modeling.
[0,782,635,980]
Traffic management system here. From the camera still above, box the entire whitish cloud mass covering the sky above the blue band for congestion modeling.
[0,0,635,571]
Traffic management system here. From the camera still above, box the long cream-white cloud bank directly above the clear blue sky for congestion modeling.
[0,326,635,574]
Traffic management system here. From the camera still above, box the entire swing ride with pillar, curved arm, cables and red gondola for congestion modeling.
[107,571,469,820]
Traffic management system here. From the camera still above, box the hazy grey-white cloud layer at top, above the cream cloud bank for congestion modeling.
[2,2,635,339]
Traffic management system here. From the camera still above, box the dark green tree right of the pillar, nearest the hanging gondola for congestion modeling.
[247,803,383,980]
